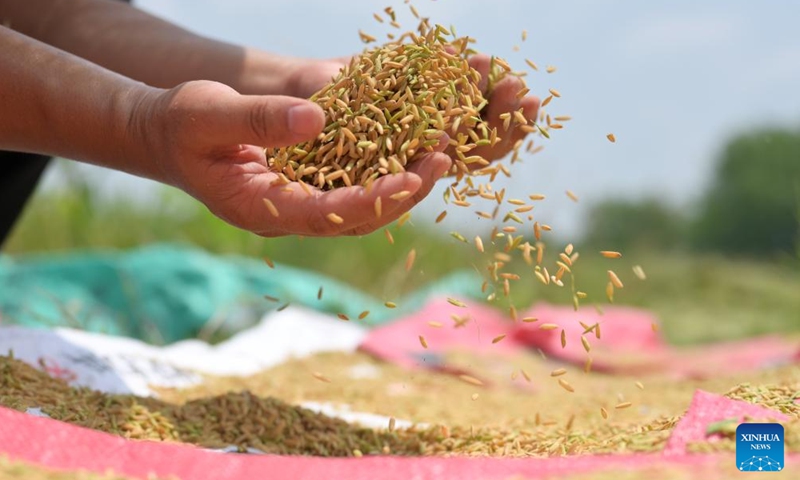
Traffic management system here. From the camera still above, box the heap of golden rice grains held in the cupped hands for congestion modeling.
[266,17,533,190]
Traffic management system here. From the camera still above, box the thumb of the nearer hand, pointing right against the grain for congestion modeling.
[216,95,325,147]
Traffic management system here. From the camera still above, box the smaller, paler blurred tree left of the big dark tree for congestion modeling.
[584,198,686,250]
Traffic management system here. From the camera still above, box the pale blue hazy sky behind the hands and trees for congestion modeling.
[42,0,800,235]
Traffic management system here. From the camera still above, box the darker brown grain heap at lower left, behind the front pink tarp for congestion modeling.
[0,357,421,456]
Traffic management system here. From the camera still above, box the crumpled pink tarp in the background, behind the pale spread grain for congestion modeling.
[359,299,800,378]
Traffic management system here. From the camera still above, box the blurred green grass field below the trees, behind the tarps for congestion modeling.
[4,165,800,344]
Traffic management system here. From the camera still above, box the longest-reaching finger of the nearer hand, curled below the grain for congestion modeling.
[343,152,453,235]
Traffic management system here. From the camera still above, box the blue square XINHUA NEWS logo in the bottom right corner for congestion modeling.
[736,423,784,472]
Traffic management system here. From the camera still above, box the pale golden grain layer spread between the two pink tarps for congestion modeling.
[155,353,800,456]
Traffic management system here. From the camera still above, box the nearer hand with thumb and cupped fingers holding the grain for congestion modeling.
[131,81,451,237]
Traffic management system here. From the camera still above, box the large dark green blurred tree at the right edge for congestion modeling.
[692,129,800,256]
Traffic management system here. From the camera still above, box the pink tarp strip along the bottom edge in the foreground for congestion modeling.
[0,392,800,480]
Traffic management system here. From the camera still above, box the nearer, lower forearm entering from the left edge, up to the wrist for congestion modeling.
[0,27,160,179]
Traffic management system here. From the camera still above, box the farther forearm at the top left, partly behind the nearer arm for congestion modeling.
[0,0,296,94]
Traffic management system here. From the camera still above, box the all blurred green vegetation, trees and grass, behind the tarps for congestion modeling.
[4,129,800,344]
